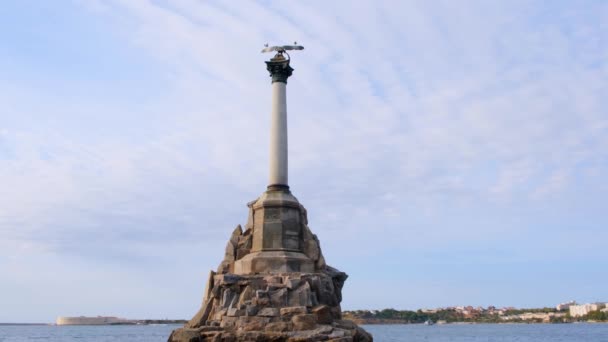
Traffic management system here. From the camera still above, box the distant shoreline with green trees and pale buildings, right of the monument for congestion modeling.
[343,301,608,324]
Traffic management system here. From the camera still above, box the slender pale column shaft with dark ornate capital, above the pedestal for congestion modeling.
[266,53,293,190]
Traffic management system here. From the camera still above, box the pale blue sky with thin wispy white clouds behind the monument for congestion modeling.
[0,0,608,322]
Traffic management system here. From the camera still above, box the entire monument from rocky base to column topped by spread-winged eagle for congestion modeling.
[169,43,373,342]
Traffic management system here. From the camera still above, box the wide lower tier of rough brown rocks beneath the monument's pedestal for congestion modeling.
[169,272,373,342]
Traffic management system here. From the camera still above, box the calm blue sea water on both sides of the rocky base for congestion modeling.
[0,323,608,342]
